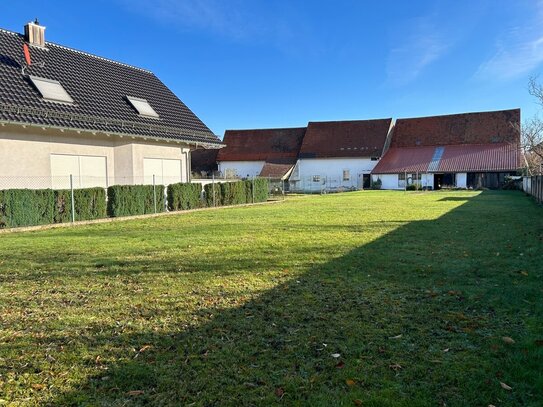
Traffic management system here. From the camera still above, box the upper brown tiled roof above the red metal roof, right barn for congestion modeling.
[390,109,520,147]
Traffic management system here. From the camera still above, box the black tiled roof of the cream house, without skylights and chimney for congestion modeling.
[0,30,220,144]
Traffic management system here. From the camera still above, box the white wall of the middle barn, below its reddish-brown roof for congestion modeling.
[289,158,378,191]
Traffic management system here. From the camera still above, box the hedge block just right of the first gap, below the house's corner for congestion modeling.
[107,185,164,218]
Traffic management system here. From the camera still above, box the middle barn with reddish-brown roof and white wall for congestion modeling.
[289,119,393,192]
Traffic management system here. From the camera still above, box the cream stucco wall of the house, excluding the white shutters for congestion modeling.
[0,125,188,189]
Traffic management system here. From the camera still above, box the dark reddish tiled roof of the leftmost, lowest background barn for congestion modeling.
[217,127,306,163]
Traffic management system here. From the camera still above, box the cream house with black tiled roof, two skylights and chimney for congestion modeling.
[0,21,222,189]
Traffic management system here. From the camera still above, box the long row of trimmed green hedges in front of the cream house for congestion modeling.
[0,179,268,229]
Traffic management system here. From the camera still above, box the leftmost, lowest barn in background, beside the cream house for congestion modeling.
[217,127,306,181]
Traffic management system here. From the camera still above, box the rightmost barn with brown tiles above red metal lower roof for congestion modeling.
[372,109,521,189]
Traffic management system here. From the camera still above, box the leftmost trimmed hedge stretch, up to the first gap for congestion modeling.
[0,188,106,229]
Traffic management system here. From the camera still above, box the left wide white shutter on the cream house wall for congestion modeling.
[51,154,107,189]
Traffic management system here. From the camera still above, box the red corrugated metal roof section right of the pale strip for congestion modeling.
[439,143,520,172]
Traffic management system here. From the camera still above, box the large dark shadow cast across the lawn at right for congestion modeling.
[41,193,542,406]
